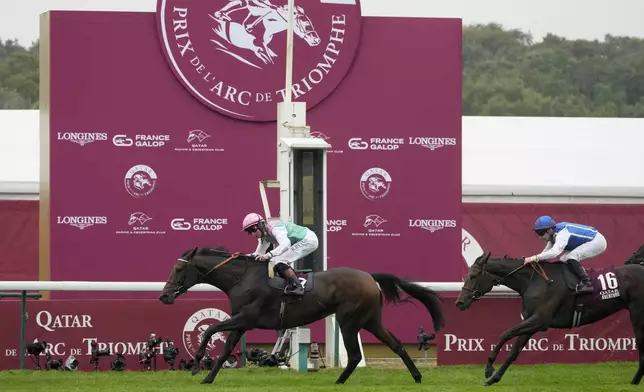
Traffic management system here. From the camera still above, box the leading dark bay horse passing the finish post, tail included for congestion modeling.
[159,247,444,384]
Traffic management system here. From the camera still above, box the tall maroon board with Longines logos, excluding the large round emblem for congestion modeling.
[42,11,461,299]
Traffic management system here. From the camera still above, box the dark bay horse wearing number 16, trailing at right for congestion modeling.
[456,245,644,386]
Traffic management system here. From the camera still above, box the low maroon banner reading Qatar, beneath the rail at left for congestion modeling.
[0,300,324,371]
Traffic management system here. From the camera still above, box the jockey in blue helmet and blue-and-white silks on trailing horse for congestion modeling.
[525,216,606,294]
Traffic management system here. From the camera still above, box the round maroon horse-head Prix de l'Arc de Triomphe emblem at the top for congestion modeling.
[157,0,361,121]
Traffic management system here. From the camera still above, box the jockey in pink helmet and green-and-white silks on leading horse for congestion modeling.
[242,212,318,295]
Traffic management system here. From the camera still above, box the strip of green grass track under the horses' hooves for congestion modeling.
[0,362,644,392]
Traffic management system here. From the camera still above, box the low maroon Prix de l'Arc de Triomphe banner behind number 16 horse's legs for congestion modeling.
[436,298,638,368]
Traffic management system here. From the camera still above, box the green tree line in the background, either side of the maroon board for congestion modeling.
[0,23,644,117]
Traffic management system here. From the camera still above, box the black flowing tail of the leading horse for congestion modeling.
[371,273,445,331]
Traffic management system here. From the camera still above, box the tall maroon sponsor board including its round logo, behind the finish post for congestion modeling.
[45,8,462,299]
